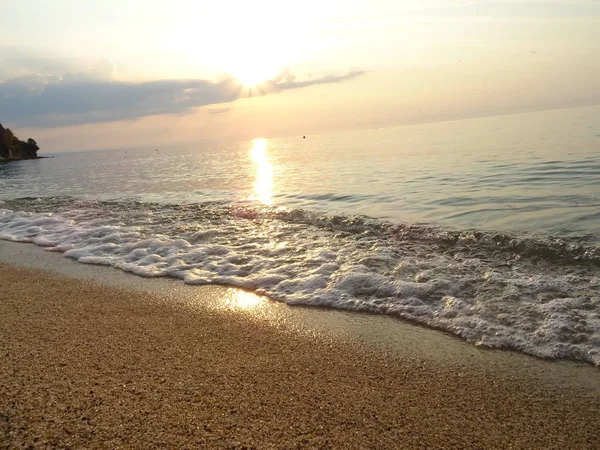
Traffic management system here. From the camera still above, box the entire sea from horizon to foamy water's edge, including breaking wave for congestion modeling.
[0,106,600,366]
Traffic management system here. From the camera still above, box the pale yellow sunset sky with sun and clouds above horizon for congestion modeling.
[0,0,600,152]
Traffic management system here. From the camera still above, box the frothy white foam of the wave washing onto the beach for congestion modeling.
[0,203,600,365]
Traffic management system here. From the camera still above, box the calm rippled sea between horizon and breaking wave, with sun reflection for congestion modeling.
[0,107,600,236]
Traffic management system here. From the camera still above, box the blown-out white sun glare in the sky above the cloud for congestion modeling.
[168,0,304,91]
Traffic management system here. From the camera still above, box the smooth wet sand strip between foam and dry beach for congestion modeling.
[0,240,600,376]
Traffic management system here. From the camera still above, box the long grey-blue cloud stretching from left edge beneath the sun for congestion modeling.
[0,60,363,127]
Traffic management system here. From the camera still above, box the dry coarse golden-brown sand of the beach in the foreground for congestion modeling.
[0,258,600,449]
